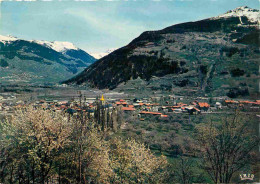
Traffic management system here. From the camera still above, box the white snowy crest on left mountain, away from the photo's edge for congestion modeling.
[32,40,79,52]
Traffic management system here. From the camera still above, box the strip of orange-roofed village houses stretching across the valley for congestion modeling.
[0,95,260,119]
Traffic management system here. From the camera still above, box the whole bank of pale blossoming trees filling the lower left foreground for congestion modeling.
[0,107,167,184]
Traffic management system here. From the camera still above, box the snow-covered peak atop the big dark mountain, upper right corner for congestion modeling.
[213,6,260,23]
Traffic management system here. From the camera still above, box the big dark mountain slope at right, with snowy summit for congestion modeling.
[65,6,260,97]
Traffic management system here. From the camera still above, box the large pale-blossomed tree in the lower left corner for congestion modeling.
[1,107,71,183]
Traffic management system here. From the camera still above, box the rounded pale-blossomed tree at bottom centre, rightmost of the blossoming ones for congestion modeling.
[110,138,167,183]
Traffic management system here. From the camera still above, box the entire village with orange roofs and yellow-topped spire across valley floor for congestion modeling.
[0,91,260,121]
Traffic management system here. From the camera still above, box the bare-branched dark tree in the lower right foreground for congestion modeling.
[196,112,259,183]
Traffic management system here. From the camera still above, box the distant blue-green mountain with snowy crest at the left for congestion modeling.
[0,35,96,83]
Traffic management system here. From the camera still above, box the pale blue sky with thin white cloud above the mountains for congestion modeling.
[0,0,259,53]
